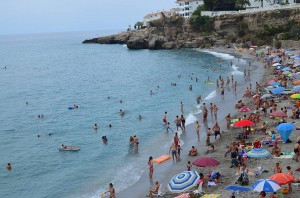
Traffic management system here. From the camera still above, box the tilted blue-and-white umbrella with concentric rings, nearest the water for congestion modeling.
[168,171,200,193]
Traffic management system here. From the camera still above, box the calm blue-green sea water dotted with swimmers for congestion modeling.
[0,33,241,198]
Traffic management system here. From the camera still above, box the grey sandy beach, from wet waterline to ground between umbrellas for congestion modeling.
[119,48,299,198]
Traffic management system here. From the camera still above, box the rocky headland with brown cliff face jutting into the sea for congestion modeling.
[83,8,300,50]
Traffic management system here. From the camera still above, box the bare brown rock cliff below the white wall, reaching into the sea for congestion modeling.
[83,8,300,50]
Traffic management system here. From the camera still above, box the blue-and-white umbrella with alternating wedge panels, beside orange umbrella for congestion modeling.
[252,179,281,193]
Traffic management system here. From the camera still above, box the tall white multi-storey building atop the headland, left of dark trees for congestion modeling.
[175,0,204,19]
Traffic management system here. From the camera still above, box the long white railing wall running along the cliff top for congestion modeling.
[201,4,300,17]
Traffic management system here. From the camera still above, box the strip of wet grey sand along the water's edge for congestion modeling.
[118,48,265,197]
